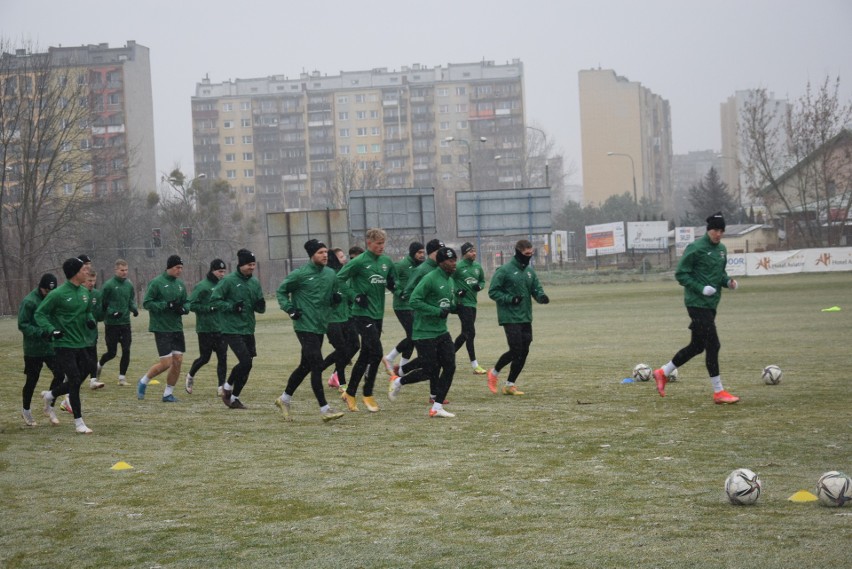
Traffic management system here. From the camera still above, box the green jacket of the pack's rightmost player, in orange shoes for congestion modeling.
[488,257,544,326]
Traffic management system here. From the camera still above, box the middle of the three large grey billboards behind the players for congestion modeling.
[349,188,437,235]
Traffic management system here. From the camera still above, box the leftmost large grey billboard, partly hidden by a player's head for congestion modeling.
[266,209,349,260]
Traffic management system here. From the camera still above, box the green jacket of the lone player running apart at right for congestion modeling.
[675,233,731,310]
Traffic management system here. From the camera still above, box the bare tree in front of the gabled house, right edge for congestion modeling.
[740,77,852,246]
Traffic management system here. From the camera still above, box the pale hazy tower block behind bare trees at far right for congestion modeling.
[719,90,789,209]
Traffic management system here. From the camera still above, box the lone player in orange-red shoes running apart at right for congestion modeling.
[654,211,740,404]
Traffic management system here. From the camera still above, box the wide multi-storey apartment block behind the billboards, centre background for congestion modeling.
[192,60,525,231]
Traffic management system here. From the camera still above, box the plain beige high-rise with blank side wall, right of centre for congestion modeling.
[579,69,673,214]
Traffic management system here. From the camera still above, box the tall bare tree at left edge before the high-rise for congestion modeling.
[0,38,94,305]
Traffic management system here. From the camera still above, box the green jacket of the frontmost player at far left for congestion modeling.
[35,281,95,348]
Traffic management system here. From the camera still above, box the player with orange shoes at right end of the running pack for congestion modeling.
[488,239,550,395]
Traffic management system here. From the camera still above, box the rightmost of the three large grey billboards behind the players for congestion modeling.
[456,188,551,238]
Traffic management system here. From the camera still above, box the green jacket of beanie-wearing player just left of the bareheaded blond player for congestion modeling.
[276,262,339,334]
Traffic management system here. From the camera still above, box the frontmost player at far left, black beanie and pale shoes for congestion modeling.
[35,257,97,435]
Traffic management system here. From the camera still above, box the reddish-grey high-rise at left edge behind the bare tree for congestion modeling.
[0,41,156,197]
